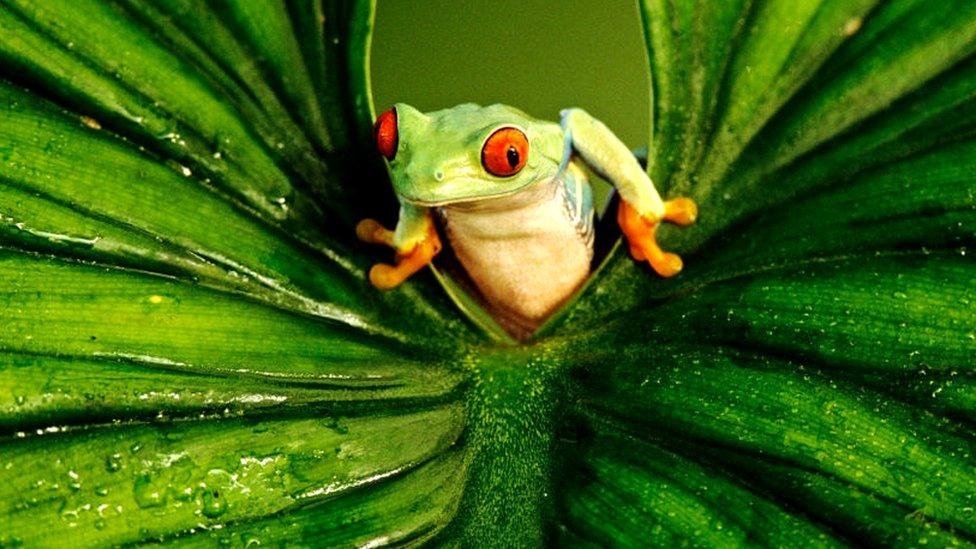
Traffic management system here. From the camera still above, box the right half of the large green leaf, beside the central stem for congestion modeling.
[555,2,976,546]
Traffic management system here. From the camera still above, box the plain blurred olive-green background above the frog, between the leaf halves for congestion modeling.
[372,0,650,148]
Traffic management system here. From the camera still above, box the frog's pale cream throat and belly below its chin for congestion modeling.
[440,182,593,337]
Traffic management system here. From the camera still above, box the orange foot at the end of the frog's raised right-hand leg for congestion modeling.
[617,198,698,278]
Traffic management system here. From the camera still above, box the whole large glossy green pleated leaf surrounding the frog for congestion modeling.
[0,0,976,547]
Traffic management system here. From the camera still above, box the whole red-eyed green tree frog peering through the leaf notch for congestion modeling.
[356,103,698,339]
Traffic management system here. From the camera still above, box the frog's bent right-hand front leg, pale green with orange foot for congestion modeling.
[561,109,698,277]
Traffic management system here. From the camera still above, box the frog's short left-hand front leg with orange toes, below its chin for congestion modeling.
[356,203,442,290]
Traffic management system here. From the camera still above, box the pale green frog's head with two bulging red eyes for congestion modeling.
[373,103,563,206]
